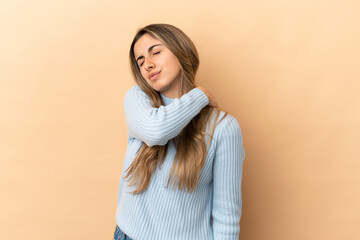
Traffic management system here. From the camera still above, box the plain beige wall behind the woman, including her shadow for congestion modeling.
[0,0,360,240]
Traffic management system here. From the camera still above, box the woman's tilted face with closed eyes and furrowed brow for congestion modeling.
[134,33,181,98]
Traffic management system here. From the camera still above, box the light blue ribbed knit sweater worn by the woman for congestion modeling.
[115,85,245,240]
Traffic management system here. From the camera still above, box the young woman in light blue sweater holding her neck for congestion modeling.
[114,24,245,240]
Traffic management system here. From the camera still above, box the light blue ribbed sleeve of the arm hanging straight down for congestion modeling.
[212,116,245,240]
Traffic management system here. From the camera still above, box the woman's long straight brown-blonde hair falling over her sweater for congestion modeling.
[125,24,227,194]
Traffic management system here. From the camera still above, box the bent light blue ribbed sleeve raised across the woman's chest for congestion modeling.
[123,85,209,147]
